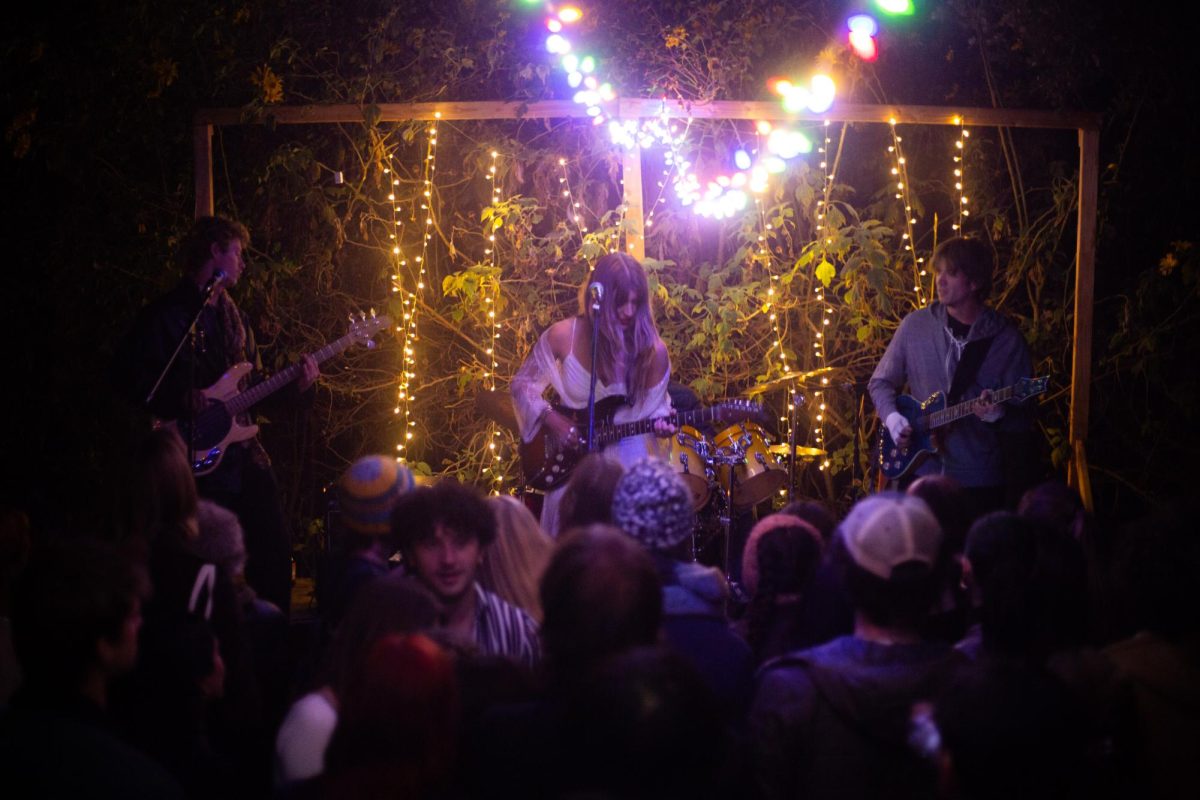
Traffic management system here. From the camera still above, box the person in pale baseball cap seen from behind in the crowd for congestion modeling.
[750,492,959,798]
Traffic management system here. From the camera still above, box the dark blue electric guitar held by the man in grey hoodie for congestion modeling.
[878,378,1050,481]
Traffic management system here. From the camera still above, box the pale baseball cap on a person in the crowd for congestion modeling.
[839,492,942,581]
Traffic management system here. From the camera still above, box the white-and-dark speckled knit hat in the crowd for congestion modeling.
[612,458,696,551]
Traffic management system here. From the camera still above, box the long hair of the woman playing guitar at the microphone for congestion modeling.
[580,253,659,405]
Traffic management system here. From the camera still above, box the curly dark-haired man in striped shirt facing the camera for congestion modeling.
[391,480,540,668]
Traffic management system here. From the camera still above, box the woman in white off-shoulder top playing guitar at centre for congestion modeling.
[511,253,674,536]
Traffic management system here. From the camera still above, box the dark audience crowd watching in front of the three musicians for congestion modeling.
[0,441,1200,799]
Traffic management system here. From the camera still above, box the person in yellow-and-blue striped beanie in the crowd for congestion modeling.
[320,456,416,631]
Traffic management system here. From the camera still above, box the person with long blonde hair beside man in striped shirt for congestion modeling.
[479,494,554,622]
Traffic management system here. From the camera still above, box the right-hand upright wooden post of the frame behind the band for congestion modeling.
[1069,127,1100,499]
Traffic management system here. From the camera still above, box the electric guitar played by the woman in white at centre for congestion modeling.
[518,396,762,492]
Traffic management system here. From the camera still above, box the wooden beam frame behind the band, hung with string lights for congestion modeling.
[193,97,1100,510]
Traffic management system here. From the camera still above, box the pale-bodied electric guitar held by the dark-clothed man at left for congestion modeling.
[155,311,391,476]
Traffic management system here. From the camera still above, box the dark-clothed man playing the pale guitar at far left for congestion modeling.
[114,217,318,614]
